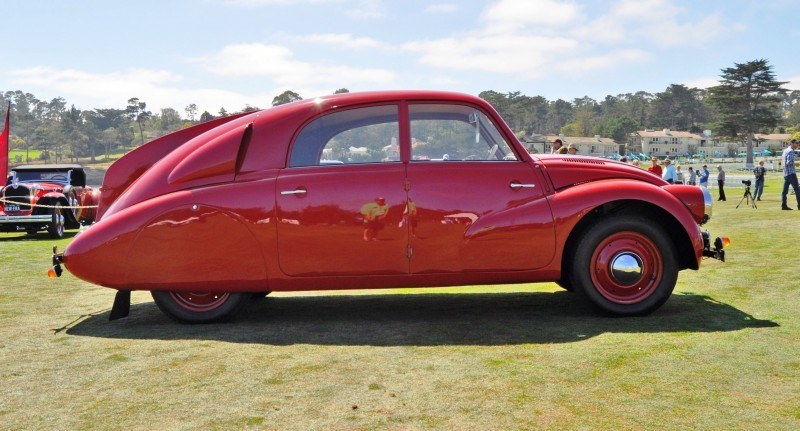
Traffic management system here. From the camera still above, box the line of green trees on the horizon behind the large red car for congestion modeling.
[0,59,800,167]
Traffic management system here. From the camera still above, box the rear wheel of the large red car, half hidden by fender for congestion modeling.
[150,290,251,323]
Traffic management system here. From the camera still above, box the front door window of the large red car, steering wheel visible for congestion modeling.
[409,104,517,161]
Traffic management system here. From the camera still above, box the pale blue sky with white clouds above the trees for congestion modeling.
[0,0,800,114]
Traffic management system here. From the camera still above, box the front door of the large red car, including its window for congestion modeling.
[407,104,555,274]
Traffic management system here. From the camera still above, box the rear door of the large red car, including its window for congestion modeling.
[276,105,409,276]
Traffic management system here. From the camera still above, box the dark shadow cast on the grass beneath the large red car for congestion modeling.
[65,292,778,346]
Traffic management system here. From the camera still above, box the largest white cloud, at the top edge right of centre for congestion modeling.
[403,0,744,79]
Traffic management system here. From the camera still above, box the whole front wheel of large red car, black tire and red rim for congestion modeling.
[568,214,678,316]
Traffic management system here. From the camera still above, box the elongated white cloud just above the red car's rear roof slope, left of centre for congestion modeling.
[194,43,395,87]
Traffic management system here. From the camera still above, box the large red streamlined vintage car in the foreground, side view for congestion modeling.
[54,91,724,322]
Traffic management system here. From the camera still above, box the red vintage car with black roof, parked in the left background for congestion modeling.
[0,165,100,238]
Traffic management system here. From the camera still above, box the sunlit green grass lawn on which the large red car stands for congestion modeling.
[0,176,800,430]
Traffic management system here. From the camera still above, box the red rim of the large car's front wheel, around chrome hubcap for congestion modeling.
[589,231,664,304]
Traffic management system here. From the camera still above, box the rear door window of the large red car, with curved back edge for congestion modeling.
[289,105,400,167]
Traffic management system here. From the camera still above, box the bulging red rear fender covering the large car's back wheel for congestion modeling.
[63,182,274,292]
